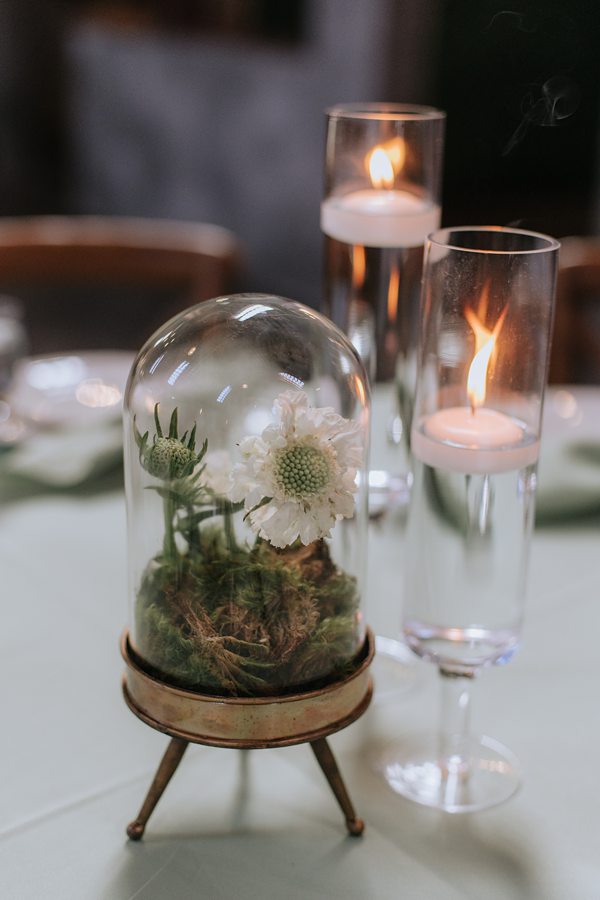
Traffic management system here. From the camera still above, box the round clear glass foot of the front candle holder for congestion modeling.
[377,737,521,813]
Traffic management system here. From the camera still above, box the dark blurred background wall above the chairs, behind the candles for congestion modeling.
[0,0,600,368]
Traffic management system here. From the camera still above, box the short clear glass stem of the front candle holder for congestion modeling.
[438,668,474,783]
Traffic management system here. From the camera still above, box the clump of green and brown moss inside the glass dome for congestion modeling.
[135,526,358,695]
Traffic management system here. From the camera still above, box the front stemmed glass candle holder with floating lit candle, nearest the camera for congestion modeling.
[384,228,559,812]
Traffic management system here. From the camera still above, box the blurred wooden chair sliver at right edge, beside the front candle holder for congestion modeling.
[549,237,600,384]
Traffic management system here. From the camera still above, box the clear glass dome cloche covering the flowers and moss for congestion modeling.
[124,294,369,696]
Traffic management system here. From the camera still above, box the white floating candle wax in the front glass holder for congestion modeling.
[411,406,539,475]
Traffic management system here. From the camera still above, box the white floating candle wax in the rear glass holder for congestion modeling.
[321,188,441,247]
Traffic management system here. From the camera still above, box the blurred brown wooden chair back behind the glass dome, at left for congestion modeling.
[0,216,241,353]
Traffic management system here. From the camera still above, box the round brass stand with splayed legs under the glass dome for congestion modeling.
[121,632,374,841]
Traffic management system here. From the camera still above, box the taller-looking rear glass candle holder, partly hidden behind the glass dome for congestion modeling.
[321,103,445,507]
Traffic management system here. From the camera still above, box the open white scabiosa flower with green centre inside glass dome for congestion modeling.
[230,391,363,547]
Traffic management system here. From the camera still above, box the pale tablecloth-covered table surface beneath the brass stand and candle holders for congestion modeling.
[0,394,600,900]
